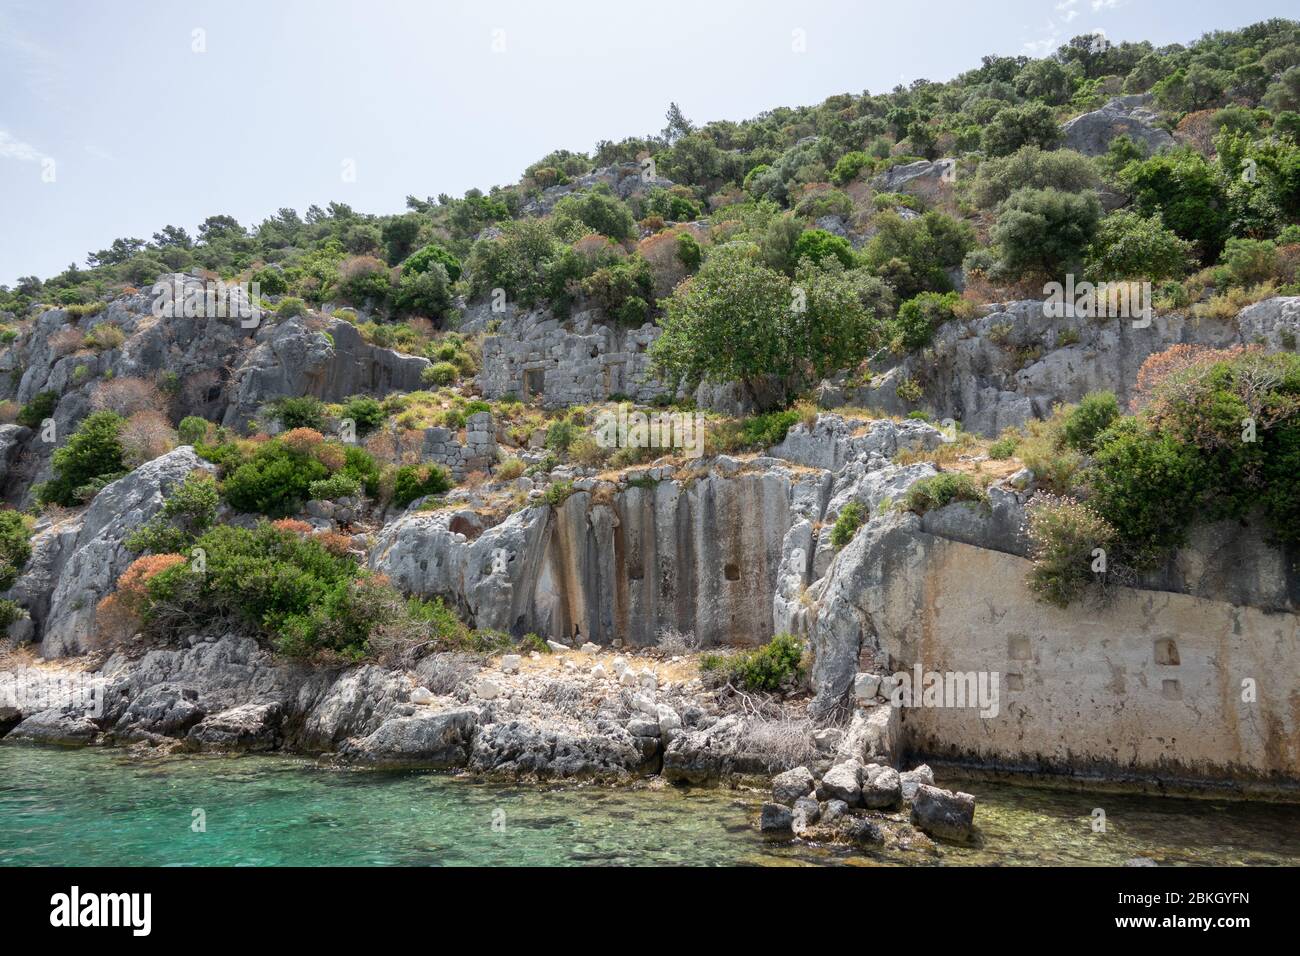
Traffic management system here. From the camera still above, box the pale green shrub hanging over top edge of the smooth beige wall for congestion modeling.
[1027,494,1117,607]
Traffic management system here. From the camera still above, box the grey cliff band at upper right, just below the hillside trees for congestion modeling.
[820,297,1300,434]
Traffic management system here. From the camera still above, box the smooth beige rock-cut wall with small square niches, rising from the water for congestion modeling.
[894,538,1300,787]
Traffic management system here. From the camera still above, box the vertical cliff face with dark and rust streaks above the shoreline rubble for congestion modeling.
[371,463,827,645]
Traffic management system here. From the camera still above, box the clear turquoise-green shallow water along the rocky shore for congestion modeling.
[0,744,1300,866]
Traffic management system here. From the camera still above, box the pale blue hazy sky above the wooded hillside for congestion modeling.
[0,0,1295,285]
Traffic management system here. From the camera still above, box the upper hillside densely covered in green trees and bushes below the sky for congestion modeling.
[0,20,1300,398]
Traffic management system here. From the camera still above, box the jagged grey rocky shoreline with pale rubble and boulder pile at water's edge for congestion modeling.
[0,635,974,848]
